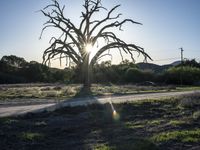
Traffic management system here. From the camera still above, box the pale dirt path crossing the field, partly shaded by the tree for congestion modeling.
[0,90,200,117]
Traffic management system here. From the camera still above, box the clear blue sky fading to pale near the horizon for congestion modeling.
[0,0,200,67]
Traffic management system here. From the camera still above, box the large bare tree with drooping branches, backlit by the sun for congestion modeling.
[40,0,151,88]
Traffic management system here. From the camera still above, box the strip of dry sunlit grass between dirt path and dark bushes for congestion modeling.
[0,84,200,102]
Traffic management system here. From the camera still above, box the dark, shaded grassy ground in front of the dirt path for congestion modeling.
[0,94,200,150]
